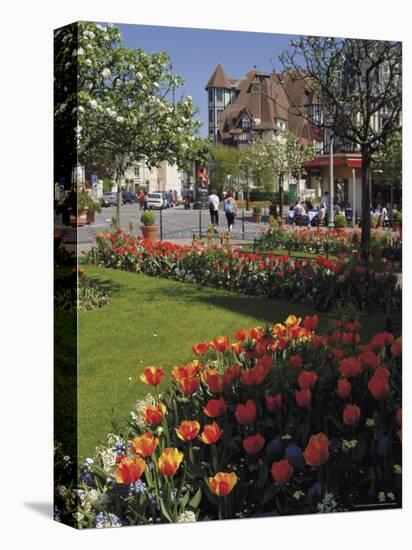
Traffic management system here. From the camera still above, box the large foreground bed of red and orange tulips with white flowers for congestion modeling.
[56,316,402,527]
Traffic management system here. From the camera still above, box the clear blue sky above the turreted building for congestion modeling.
[116,24,293,137]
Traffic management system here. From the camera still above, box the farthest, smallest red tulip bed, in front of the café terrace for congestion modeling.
[257,225,401,256]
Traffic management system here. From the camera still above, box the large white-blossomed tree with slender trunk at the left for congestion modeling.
[55,22,205,224]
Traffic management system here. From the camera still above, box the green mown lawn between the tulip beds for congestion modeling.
[56,266,383,457]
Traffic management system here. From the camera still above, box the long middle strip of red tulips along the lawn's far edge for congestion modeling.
[87,231,396,310]
